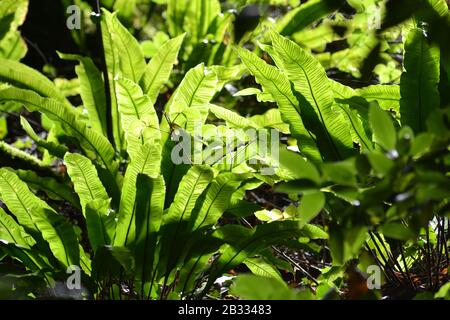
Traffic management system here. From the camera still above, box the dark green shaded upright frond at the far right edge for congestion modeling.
[400,28,440,132]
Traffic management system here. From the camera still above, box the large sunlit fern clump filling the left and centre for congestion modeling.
[0,6,326,299]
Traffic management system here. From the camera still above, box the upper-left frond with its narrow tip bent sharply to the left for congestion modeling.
[60,54,107,136]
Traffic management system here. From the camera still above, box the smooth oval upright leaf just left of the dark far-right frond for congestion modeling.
[369,104,397,151]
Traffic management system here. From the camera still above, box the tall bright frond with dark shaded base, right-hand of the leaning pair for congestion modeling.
[271,32,353,160]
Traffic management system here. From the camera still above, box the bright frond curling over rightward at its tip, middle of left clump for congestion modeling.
[114,144,161,246]
